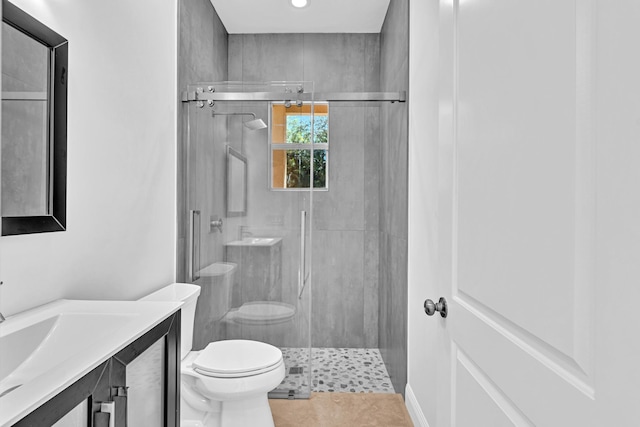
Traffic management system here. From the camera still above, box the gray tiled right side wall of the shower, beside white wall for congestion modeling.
[379,0,409,393]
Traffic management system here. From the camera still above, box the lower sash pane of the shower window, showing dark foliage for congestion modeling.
[272,150,329,188]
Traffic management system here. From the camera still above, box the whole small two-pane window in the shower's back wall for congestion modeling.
[270,103,329,190]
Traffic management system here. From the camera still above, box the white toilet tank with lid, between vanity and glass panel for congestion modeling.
[140,283,200,359]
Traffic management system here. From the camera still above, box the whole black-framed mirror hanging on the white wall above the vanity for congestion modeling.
[0,0,69,236]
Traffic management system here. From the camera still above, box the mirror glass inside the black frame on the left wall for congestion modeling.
[2,22,49,216]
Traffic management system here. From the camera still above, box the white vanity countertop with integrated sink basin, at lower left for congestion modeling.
[0,300,180,426]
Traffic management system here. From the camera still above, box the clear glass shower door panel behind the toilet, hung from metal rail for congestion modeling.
[183,82,318,398]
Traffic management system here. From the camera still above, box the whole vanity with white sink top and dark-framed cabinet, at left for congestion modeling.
[0,300,180,427]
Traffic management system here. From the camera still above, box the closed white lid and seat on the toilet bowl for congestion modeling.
[193,340,282,377]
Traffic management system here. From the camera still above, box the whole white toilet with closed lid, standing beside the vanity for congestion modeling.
[142,283,285,427]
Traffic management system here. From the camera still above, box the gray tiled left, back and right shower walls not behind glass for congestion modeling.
[177,4,408,384]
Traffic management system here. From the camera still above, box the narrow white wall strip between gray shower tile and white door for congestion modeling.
[406,0,442,426]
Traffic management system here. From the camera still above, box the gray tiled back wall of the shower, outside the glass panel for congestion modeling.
[229,34,380,347]
